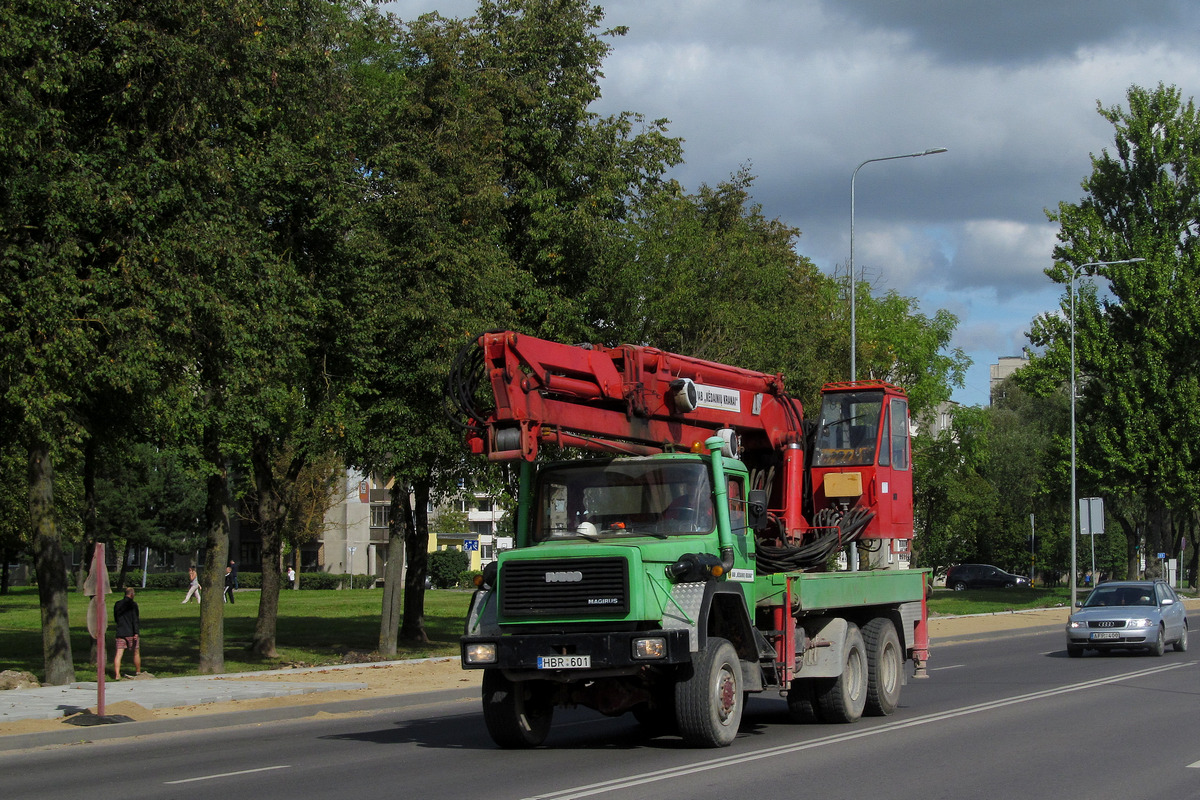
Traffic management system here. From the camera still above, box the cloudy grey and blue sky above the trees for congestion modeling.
[385,0,1200,405]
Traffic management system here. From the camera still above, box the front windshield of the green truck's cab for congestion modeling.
[534,461,715,541]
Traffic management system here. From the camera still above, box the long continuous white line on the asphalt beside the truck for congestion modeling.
[526,661,1196,800]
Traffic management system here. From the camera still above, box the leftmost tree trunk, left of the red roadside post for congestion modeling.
[29,441,74,686]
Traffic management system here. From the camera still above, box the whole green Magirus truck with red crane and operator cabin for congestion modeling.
[449,332,928,747]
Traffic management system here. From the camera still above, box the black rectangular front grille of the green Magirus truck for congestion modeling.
[499,557,629,616]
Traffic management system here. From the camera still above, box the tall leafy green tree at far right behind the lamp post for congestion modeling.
[1031,84,1200,573]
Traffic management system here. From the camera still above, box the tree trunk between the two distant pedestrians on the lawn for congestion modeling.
[198,432,229,674]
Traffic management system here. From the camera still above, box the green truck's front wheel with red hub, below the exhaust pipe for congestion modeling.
[676,637,744,747]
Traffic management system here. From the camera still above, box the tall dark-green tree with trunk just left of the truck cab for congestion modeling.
[356,0,678,643]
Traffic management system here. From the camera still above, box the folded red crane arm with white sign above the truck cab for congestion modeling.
[468,331,803,461]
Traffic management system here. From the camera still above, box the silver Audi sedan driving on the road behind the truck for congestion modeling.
[1067,581,1188,658]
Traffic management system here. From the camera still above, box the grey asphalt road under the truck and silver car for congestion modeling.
[0,619,1200,800]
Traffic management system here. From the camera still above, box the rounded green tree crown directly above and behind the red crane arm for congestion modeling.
[588,168,836,407]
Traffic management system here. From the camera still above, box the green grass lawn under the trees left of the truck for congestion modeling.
[0,587,470,680]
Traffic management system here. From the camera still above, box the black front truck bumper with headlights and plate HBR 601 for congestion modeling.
[461,630,691,680]
